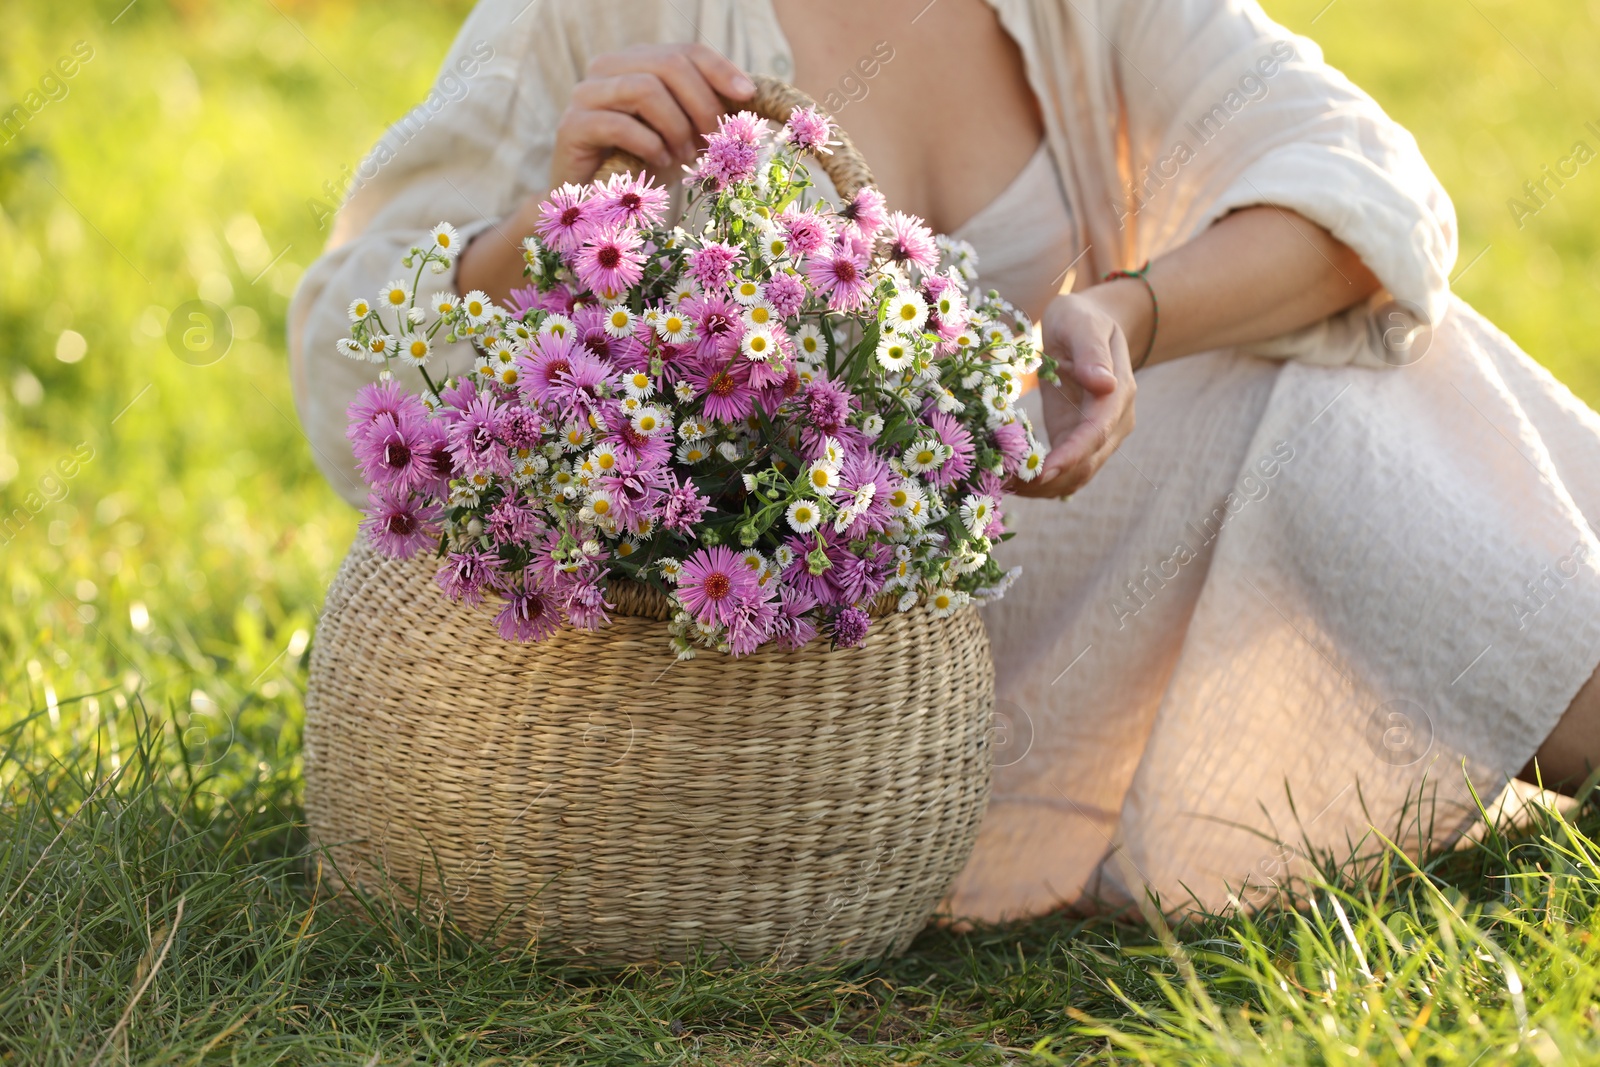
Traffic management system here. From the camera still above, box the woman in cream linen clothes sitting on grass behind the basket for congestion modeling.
[290,0,1600,918]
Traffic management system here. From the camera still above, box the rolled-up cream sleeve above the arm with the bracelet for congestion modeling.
[1102,0,1456,366]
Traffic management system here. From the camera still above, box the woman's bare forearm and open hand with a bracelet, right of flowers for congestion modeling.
[1016,206,1379,498]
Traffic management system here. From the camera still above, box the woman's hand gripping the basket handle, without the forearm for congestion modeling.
[550,43,755,186]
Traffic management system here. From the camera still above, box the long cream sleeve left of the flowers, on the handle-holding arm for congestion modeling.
[288,0,582,507]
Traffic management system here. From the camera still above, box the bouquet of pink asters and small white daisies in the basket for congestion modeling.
[339,109,1054,657]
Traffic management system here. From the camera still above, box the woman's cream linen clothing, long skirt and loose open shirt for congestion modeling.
[290,0,1600,918]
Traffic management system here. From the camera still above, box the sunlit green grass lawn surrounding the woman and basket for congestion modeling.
[0,0,1600,1065]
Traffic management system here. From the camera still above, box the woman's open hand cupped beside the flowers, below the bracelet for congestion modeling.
[1013,278,1152,498]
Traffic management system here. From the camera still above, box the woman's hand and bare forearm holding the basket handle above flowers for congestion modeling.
[456,45,755,302]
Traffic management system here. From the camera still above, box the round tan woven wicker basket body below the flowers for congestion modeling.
[306,541,994,963]
